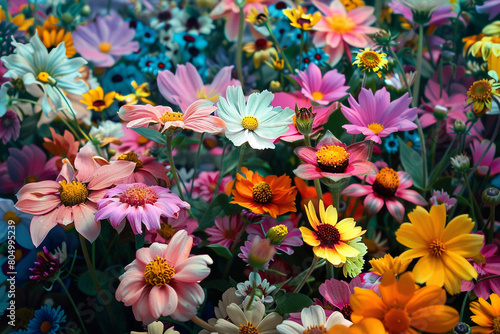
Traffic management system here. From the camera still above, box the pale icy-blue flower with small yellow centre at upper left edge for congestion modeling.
[2,33,89,116]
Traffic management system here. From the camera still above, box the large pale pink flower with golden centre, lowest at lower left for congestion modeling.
[115,231,212,324]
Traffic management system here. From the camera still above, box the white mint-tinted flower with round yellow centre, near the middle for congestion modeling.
[217,86,295,150]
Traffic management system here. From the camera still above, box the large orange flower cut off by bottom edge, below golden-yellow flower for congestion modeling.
[351,272,459,334]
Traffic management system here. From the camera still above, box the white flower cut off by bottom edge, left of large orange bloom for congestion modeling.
[276,305,352,334]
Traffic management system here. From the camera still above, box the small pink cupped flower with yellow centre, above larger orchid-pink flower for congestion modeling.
[291,63,349,105]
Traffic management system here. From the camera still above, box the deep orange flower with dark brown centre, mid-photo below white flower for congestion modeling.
[231,167,297,218]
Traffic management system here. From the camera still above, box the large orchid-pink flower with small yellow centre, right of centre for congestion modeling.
[341,87,417,144]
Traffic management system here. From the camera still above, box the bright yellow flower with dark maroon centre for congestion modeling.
[300,200,365,266]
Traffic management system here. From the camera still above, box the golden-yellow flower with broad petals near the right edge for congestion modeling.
[396,204,484,294]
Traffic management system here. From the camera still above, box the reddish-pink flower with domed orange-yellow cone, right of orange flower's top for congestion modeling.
[293,131,376,181]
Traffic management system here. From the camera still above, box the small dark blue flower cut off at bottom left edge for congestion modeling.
[26,305,66,334]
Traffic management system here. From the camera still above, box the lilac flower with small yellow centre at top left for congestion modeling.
[73,14,139,67]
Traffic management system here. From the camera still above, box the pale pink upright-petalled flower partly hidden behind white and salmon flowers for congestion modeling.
[157,63,241,110]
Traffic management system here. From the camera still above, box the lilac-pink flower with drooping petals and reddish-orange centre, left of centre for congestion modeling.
[95,183,190,234]
